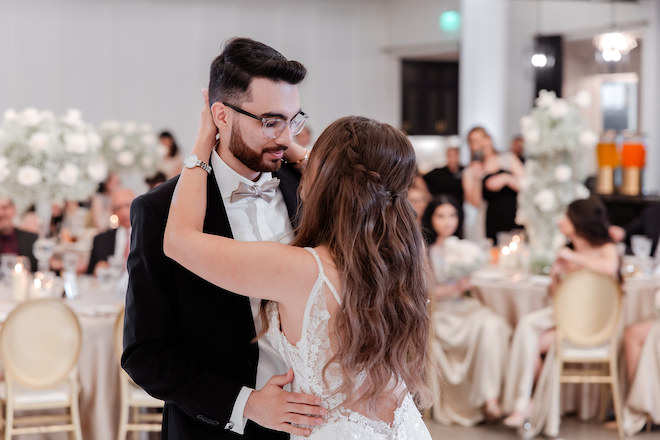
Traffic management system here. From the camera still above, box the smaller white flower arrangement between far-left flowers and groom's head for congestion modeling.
[99,121,162,177]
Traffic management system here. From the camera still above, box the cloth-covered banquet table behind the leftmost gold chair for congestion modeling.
[0,276,124,440]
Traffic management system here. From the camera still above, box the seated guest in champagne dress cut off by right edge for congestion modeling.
[621,318,660,436]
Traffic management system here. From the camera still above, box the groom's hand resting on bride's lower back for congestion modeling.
[243,370,327,436]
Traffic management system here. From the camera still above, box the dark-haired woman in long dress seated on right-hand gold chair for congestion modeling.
[502,196,620,427]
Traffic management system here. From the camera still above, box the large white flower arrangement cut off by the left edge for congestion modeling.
[0,108,107,208]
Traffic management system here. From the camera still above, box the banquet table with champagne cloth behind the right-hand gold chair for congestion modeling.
[470,267,660,420]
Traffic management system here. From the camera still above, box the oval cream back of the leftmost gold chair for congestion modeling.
[0,298,82,390]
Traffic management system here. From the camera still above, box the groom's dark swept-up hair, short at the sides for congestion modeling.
[209,38,307,105]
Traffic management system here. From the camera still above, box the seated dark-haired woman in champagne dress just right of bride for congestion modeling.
[422,195,511,426]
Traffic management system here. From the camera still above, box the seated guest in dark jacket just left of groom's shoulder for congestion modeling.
[87,188,135,275]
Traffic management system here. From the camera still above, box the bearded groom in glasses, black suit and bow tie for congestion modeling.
[122,38,320,440]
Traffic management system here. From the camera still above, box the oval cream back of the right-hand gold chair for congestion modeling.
[554,269,622,347]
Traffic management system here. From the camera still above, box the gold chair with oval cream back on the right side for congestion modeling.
[554,269,623,437]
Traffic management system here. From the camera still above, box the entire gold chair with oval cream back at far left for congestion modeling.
[0,298,82,440]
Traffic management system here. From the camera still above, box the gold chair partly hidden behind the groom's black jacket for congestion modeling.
[115,309,164,440]
